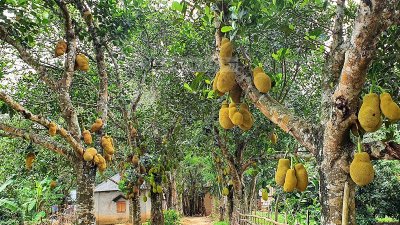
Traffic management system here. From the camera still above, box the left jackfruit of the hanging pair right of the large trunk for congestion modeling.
[358,93,382,132]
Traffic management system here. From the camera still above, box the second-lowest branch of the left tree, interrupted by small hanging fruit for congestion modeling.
[0,91,84,155]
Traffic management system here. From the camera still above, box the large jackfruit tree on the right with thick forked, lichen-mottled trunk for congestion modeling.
[209,0,400,224]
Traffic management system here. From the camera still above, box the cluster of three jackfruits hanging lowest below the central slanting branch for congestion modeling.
[219,101,254,131]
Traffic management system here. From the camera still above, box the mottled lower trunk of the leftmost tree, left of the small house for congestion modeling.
[76,160,96,225]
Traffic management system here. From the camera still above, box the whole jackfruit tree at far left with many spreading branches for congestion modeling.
[0,1,112,224]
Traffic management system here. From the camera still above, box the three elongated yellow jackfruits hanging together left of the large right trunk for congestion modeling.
[275,159,308,192]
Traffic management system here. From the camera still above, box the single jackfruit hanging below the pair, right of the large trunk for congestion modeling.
[350,152,375,187]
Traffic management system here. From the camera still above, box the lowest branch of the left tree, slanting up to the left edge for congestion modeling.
[0,123,71,158]
